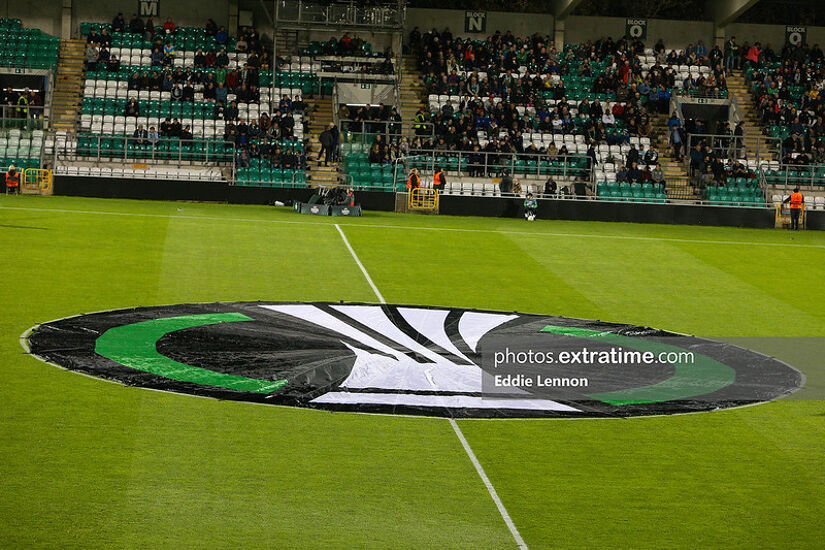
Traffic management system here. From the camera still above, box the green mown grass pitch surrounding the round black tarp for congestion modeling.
[0,197,825,549]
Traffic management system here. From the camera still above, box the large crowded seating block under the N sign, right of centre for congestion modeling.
[345,31,740,200]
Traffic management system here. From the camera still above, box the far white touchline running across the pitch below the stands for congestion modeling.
[0,206,825,250]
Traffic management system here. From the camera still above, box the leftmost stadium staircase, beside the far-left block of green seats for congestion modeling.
[51,39,86,132]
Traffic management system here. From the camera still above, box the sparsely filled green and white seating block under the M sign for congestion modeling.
[58,18,310,185]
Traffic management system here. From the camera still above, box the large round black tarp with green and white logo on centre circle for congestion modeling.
[27,302,804,417]
